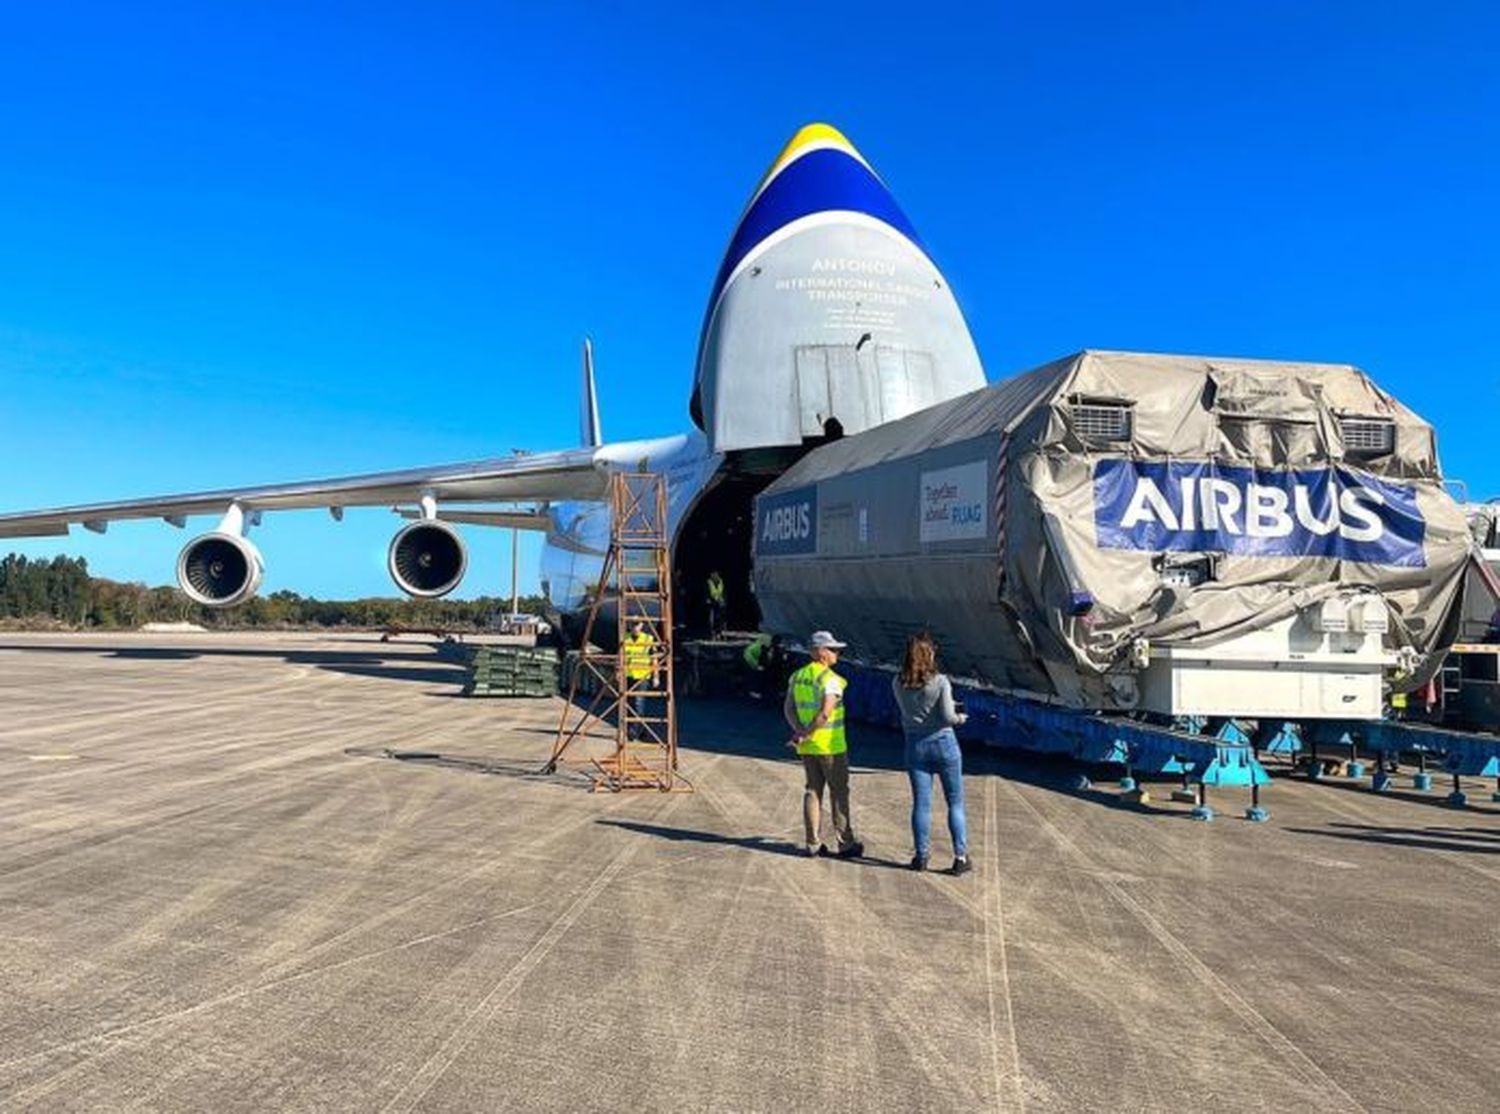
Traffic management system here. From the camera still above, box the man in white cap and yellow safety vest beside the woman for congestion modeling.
[782,631,864,859]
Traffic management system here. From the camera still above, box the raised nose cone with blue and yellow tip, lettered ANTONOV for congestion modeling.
[693,124,984,453]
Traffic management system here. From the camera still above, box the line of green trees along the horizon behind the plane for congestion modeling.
[0,553,543,630]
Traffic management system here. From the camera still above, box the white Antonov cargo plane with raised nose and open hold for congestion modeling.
[0,124,984,641]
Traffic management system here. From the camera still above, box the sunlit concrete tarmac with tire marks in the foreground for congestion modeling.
[0,634,1500,1111]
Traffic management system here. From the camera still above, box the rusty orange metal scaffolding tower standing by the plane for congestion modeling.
[545,472,690,792]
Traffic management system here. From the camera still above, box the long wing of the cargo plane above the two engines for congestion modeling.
[0,447,609,538]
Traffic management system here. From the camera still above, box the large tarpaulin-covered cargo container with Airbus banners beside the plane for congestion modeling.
[755,351,1473,706]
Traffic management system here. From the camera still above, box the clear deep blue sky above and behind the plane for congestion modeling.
[0,1,1500,597]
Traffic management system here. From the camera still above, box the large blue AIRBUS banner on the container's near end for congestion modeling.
[1094,460,1427,568]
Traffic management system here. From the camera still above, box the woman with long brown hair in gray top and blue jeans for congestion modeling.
[891,634,969,874]
